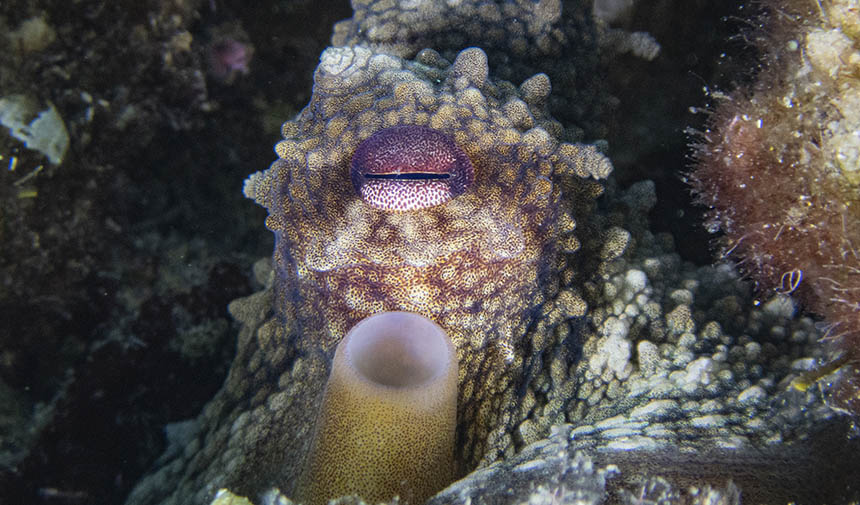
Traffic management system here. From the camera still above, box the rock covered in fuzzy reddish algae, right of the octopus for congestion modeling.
[690,0,860,414]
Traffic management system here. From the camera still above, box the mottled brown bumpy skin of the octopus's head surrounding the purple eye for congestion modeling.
[246,44,607,480]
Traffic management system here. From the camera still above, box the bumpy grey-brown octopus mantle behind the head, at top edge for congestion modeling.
[332,0,612,140]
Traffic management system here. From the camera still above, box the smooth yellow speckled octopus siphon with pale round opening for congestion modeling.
[296,312,457,505]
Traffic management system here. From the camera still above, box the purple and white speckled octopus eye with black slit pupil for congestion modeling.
[350,125,475,211]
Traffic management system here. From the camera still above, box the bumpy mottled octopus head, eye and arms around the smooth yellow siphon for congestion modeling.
[127,3,860,505]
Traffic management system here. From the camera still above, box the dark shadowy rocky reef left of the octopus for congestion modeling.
[0,0,348,504]
